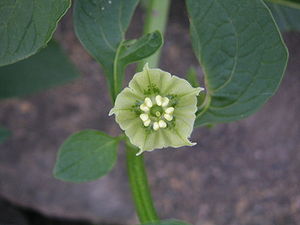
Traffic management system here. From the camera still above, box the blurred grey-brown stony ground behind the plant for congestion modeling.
[0,1,300,225]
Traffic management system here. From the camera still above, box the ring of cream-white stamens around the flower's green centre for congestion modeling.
[140,95,174,131]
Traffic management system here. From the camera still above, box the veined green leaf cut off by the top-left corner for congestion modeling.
[0,0,71,66]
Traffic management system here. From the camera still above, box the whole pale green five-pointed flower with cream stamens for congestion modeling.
[109,64,203,155]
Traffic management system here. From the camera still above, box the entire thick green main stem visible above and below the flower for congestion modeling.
[126,0,170,223]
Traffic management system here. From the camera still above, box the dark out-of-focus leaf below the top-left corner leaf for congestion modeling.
[0,41,79,99]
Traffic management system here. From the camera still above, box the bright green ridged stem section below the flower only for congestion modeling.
[126,143,159,223]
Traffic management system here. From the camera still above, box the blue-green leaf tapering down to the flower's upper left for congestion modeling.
[74,0,139,99]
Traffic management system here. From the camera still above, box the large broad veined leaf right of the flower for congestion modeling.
[187,0,288,126]
